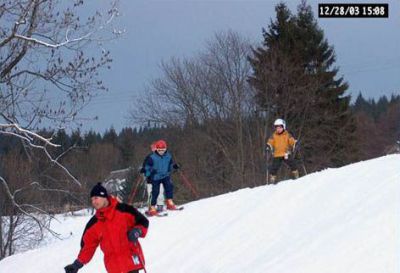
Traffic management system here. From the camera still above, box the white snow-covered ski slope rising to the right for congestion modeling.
[0,155,400,273]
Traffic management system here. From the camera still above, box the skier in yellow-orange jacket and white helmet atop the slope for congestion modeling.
[267,119,299,183]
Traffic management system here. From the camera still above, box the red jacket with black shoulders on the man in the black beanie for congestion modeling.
[78,198,149,273]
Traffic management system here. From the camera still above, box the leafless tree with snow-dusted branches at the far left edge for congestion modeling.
[0,0,121,258]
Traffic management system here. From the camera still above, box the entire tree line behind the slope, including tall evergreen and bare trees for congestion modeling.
[0,2,400,242]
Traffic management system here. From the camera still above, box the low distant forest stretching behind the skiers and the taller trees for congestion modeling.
[0,94,400,206]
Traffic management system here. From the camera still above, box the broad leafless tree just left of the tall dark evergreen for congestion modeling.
[131,31,260,191]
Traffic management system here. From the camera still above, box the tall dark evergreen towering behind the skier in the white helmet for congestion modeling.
[249,1,357,169]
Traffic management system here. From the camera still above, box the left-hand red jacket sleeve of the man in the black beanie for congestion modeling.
[78,216,100,264]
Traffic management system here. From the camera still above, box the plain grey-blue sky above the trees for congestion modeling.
[82,0,400,132]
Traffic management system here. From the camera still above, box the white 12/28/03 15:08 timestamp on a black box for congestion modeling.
[318,3,389,18]
